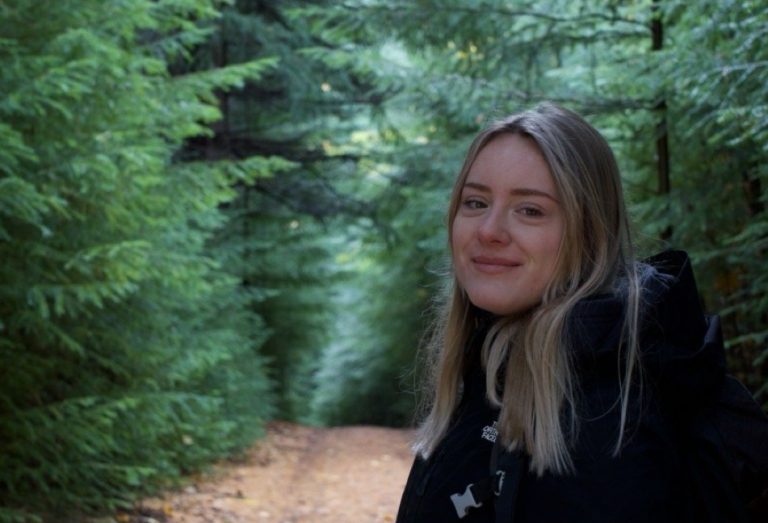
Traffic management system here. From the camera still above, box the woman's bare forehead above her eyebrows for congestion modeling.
[464,133,557,196]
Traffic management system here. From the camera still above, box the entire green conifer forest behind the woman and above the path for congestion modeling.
[0,0,768,521]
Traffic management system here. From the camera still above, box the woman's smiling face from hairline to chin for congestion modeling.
[451,134,564,316]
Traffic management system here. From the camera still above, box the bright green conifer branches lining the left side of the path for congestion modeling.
[0,0,284,520]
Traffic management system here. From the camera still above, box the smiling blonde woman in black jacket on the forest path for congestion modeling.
[397,104,760,523]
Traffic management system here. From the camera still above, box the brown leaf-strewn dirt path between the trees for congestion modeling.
[124,422,413,523]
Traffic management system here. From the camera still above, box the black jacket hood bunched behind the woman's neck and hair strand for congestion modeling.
[569,251,725,408]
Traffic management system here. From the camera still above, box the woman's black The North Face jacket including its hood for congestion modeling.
[397,252,752,523]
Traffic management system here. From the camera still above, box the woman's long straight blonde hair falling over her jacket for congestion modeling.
[414,104,640,474]
